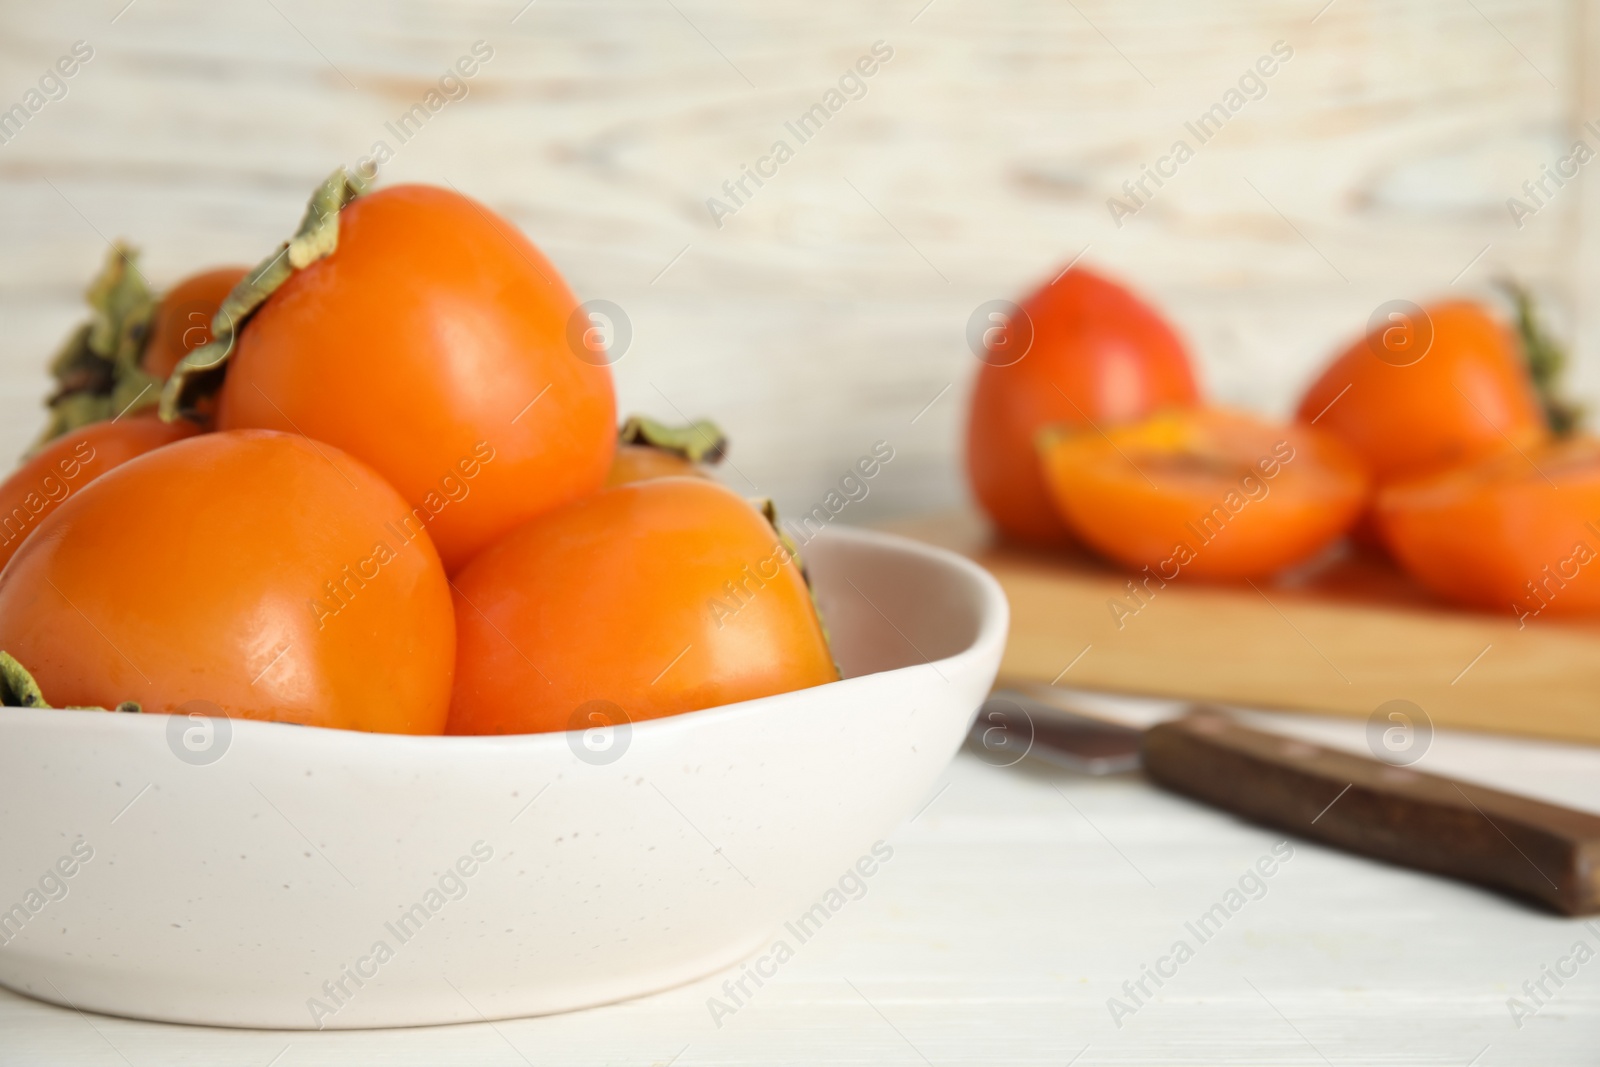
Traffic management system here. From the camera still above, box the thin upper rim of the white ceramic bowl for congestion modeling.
[0,526,1010,755]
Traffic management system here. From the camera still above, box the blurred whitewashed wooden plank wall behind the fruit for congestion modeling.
[0,0,1600,522]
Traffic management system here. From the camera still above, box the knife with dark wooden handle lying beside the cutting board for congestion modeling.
[970,689,1600,915]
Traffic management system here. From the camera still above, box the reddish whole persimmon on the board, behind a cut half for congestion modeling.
[966,267,1198,545]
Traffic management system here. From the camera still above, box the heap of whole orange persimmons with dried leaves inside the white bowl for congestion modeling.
[0,176,838,734]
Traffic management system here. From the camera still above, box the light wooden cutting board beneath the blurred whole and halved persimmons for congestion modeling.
[886,514,1600,744]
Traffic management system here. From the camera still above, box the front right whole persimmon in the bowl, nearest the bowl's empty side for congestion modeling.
[448,478,838,734]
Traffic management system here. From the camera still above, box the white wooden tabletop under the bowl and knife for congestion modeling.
[0,701,1600,1067]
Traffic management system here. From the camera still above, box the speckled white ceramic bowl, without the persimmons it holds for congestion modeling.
[0,528,1008,1029]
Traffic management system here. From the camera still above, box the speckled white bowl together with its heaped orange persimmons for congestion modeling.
[0,171,1006,1029]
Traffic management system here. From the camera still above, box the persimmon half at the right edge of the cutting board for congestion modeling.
[1374,437,1600,616]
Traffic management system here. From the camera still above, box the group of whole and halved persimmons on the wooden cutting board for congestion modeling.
[966,267,1600,619]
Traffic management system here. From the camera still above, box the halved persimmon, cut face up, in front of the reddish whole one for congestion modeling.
[1042,408,1368,581]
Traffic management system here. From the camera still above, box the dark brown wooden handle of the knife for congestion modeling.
[1141,709,1600,915]
